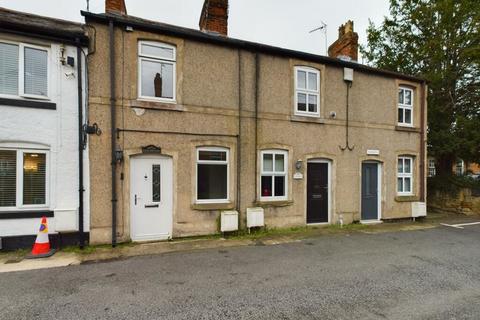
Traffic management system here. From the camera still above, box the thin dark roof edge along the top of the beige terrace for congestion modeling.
[81,11,425,82]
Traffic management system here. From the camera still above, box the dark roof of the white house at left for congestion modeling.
[0,7,88,44]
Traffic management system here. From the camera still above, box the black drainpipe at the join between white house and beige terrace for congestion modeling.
[75,38,85,249]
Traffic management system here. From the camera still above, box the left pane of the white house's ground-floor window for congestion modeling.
[0,150,17,207]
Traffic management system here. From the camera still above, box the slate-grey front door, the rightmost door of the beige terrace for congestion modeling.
[362,162,378,220]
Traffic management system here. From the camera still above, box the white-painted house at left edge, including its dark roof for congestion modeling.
[0,8,90,250]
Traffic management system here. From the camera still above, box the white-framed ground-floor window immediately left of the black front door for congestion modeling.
[260,150,288,200]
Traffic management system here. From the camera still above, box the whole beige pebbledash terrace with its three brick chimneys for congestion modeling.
[82,0,427,243]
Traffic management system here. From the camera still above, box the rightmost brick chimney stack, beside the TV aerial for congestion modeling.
[328,20,358,61]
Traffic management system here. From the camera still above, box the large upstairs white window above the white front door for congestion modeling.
[138,41,176,101]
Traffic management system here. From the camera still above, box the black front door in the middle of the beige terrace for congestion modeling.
[307,162,329,223]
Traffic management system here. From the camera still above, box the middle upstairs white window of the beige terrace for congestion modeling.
[295,67,320,117]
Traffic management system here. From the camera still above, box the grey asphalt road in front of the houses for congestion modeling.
[0,211,480,320]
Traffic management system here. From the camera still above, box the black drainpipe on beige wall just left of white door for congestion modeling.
[108,20,117,247]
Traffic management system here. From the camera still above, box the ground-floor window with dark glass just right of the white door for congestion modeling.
[197,147,229,203]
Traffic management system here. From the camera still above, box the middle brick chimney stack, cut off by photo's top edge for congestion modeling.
[198,0,228,36]
